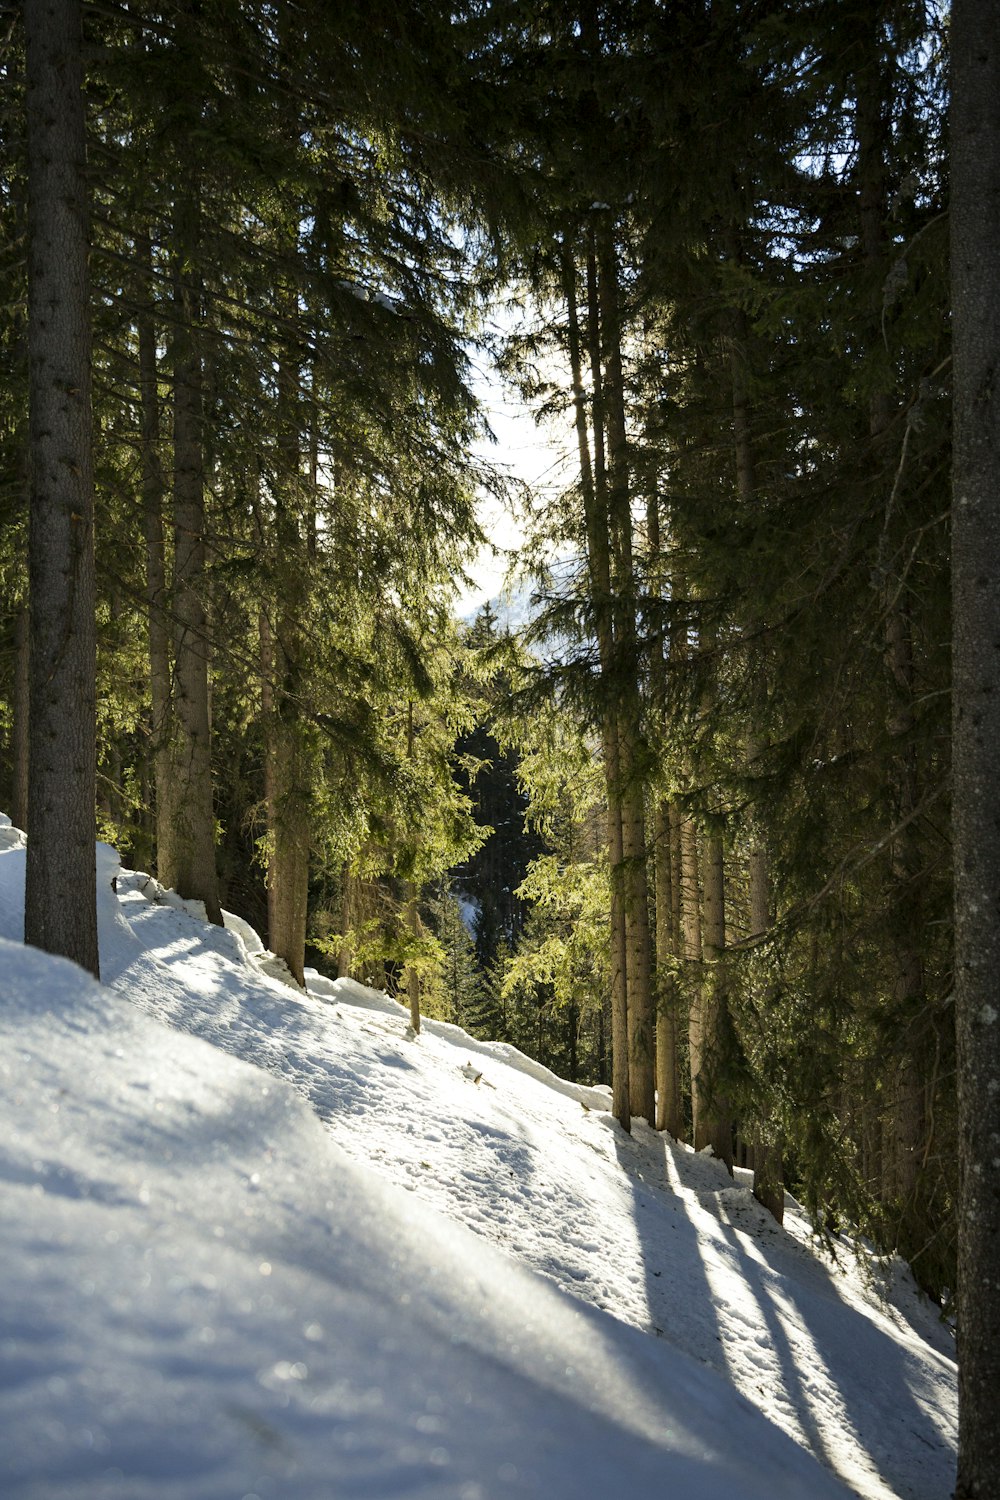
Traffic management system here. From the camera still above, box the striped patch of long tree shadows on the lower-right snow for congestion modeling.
[613,1121,954,1500]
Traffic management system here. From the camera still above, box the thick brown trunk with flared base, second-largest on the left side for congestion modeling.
[157,194,222,924]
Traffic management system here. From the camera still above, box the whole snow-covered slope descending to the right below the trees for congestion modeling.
[0,822,955,1500]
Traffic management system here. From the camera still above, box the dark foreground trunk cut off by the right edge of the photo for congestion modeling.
[951,0,1000,1500]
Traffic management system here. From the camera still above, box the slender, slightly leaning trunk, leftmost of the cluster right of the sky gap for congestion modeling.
[562,251,631,1130]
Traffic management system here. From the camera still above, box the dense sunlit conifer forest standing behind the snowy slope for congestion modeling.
[0,0,957,1301]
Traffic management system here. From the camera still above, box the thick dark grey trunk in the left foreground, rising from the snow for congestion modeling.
[24,0,99,975]
